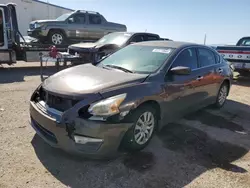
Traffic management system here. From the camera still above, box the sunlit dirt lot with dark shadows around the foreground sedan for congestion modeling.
[0,64,250,188]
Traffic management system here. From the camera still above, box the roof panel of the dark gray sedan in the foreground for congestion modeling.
[133,40,199,48]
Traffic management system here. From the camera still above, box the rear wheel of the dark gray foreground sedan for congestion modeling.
[214,82,229,108]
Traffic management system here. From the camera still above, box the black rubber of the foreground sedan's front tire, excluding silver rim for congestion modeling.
[122,105,158,151]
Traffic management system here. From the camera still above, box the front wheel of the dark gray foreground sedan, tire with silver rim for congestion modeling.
[121,105,158,152]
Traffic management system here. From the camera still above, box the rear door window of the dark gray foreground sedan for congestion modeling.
[198,48,216,67]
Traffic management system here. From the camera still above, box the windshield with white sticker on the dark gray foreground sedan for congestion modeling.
[97,45,173,73]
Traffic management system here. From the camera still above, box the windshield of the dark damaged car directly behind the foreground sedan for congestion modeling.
[96,33,132,46]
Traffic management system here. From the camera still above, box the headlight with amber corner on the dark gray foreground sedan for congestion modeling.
[88,93,127,116]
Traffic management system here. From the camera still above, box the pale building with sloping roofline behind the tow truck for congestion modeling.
[0,0,74,36]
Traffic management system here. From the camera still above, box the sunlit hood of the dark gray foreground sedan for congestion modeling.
[42,64,148,98]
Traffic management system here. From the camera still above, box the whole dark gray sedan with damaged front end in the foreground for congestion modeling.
[30,41,233,157]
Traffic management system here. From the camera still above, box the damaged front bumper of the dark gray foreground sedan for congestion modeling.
[30,101,132,158]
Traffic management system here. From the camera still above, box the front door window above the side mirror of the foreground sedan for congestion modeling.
[172,48,198,70]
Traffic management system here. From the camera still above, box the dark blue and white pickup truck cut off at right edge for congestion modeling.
[216,37,250,75]
